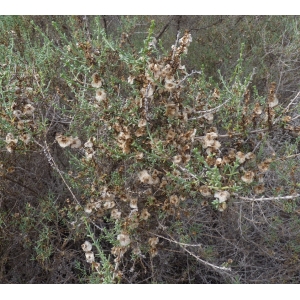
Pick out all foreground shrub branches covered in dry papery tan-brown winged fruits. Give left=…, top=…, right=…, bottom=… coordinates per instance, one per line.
left=1, top=17, right=299, bottom=283
